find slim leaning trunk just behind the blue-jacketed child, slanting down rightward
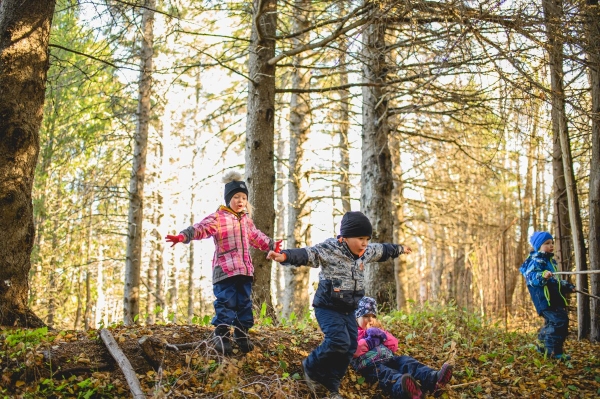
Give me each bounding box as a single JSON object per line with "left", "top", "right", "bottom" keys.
{"left": 542, "top": 0, "right": 590, "bottom": 339}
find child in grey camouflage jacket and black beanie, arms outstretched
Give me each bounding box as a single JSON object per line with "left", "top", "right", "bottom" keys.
{"left": 267, "top": 212, "right": 412, "bottom": 399}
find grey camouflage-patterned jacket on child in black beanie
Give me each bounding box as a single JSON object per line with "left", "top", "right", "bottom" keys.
{"left": 281, "top": 238, "right": 404, "bottom": 313}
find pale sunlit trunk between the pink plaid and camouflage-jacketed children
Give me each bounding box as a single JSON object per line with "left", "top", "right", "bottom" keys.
{"left": 282, "top": 0, "right": 311, "bottom": 318}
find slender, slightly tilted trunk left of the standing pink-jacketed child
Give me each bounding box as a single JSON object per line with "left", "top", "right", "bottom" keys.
{"left": 123, "top": 0, "right": 156, "bottom": 325}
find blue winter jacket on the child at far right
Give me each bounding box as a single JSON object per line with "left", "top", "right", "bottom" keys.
{"left": 519, "top": 251, "right": 575, "bottom": 315}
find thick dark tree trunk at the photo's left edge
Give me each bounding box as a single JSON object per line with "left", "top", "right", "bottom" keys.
{"left": 0, "top": 0, "right": 55, "bottom": 327}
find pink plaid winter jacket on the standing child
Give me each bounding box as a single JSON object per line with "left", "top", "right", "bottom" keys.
{"left": 181, "top": 206, "right": 273, "bottom": 283}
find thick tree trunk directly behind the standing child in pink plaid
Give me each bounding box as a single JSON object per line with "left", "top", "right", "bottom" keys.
{"left": 246, "top": 0, "right": 277, "bottom": 315}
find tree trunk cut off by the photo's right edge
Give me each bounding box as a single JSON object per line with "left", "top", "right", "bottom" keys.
{"left": 586, "top": 0, "right": 600, "bottom": 342}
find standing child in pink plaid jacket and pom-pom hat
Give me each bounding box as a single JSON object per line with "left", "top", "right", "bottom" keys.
{"left": 166, "top": 172, "right": 277, "bottom": 355}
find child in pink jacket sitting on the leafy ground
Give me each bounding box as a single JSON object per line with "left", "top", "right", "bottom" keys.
{"left": 351, "top": 296, "right": 452, "bottom": 399}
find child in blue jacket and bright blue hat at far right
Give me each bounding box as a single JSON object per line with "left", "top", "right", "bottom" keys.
{"left": 519, "top": 231, "right": 575, "bottom": 360}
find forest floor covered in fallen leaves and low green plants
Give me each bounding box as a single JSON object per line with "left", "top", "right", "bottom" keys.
{"left": 0, "top": 307, "right": 600, "bottom": 399}
